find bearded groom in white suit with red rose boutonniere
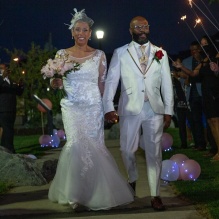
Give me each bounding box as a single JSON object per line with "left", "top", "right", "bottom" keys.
{"left": 103, "top": 16, "right": 173, "bottom": 211}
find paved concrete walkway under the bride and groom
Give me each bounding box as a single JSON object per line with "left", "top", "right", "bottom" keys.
{"left": 0, "top": 132, "right": 207, "bottom": 219}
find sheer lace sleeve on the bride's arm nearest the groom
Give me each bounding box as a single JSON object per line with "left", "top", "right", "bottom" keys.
{"left": 98, "top": 52, "right": 107, "bottom": 96}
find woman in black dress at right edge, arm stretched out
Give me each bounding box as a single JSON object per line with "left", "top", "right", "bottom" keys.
{"left": 173, "top": 45, "right": 219, "bottom": 161}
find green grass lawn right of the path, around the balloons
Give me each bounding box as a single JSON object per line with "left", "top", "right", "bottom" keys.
{"left": 163, "top": 129, "right": 219, "bottom": 219}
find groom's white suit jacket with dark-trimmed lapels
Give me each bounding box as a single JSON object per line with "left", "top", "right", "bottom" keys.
{"left": 103, "top": 42, "right": 173, "bottom": 116}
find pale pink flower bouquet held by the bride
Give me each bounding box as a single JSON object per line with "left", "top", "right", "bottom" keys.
{"left": 41, "top": 54, "right": 80, "bottom": 98}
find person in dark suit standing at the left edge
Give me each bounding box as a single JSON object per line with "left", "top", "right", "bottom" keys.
{"left": 0, "top": 64, "right": 24, "bottom": 153}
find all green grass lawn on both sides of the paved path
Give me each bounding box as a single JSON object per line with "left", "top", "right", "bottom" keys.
{"left": 0, "top": 128, "right": 219, "bottom": 219}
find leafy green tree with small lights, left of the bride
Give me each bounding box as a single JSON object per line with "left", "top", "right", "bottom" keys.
{"left": 6, "top": 43, "right": 60, "bottom": 127}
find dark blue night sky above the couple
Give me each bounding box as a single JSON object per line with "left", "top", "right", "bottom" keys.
{"left": 0, "top": 0, "right": 219, "bottom": 62}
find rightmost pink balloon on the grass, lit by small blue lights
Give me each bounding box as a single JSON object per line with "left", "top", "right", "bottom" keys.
{"left": 179, "top": 159, "right": 201, "bottom": 180}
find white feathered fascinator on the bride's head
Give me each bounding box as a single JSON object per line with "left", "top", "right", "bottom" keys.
{"left": 66, "top": 8, "right": 94, "bottom": 30}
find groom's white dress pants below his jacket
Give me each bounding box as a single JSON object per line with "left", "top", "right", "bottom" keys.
{"left": 119, "top": 101, "right": 164, "bottom": 196}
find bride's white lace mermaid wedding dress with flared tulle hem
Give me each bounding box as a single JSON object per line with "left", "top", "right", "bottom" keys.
{"left": 48, "top": 50, "right": 134, "bottom": 210}
